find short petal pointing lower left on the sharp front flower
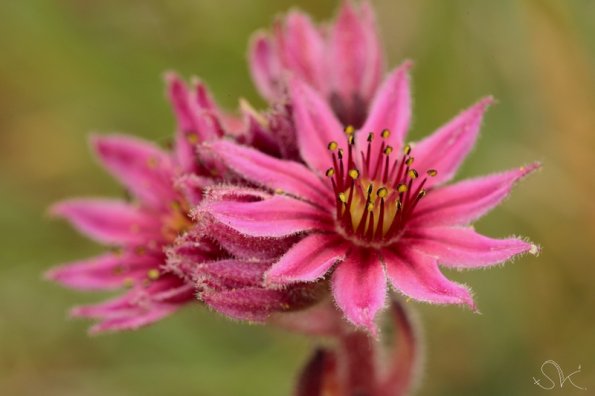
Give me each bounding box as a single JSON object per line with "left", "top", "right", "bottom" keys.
{"left": 265, "top": 234, "right": 348, "bottom": 284}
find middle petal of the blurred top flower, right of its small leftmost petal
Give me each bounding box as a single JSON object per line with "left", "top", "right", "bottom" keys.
{"left": 275, "top": 11, "right": 329, "bottom": 92}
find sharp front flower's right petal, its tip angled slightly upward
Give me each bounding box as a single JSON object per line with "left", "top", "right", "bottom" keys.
{"left": 410, "top": 163, "right": 541, "bottom": 227}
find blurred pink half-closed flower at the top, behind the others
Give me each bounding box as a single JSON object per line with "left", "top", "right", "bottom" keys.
{"left": 249, "top": 1, "right": 384, "bottom": 126}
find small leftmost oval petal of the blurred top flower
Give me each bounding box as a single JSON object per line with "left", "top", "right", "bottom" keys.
{"left": 248, "top": 32, "right": 281, "bottom": 101}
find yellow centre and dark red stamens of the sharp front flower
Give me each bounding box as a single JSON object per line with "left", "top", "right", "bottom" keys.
{"left": 326, "top": 126, "right": 438, "bottom": 243}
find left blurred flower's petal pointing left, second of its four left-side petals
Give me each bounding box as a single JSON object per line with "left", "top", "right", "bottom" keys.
{"left": 50, "top": 199, "right": 161, "bottom": 245}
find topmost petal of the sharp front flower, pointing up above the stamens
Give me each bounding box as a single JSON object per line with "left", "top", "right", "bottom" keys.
{"left": 357, "top": 61, "right": 412, "bottom": 158}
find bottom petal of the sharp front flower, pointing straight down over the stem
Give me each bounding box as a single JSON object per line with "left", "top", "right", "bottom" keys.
{"left": 332, "top": 248, "right": 386, "bottom": 335}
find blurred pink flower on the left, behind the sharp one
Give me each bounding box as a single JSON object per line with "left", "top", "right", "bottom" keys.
{"left": 47, "top": 74, "right": 240, "bottom": 333}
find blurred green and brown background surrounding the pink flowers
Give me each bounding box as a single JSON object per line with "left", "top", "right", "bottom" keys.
{"left": 0, "top": 0, "right": 595, "bottom": 396}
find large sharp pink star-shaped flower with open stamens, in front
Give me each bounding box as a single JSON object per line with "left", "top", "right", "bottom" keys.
{"left": 202, "top": 62, "right": 539, "bottom": 333}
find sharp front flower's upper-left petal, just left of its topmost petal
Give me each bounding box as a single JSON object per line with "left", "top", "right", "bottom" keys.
{"left": 289, "top": 78, "right": 346, "bottom": 174}
